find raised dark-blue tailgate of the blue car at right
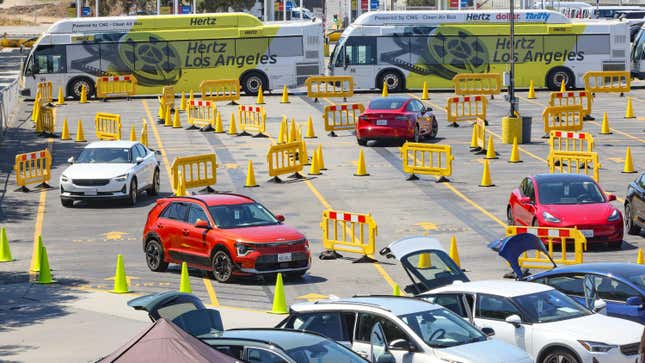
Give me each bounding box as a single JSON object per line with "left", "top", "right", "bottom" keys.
{"left": 488, "top": 233, "right": 557, "bottom": 280}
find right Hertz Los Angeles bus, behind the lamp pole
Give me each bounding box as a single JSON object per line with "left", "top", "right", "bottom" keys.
{"left": 327, "top": 10, "right": 630, "bottom": 91}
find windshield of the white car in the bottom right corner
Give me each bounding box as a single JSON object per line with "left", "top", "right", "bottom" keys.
{"left": 512, "top": 290, "right": 591, "bottom": 323}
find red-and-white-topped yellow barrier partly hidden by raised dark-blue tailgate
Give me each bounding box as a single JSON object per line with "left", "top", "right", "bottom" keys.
{"left": 506, "top": 226, "right": 587, "bottom": 269}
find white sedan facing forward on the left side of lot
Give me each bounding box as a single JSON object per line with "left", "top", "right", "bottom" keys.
{"left": 60, "top": 141, "right": 159, "bottom": 207}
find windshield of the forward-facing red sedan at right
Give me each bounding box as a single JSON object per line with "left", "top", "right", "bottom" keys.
{"left": 538, "top": 180, "right": 605, "bottom": 204}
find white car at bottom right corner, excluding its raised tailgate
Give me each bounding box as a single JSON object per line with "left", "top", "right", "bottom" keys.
{"left": 417, "top": 280, "right": 643, "bottom": 363}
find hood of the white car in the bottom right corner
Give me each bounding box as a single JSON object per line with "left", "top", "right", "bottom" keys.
{"left": 539, "top": 314, "right": 643, "bottom": 345}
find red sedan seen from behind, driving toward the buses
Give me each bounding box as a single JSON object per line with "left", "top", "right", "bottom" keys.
{"left": 356, "top": 96, "right": 438, "bottom": 146}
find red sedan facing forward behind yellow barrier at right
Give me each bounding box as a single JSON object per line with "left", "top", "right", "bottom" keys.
{"left": 506, "top": 174, "right": 623, "bottom": 248}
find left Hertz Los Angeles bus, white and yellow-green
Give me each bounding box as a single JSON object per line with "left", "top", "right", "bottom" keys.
{"left": 21, "top": 13, "right": 324, "bottom": 98}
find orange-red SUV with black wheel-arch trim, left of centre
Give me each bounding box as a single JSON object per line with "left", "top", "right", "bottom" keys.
{"left": 143, "top": 193, "right": 311, "bottom": 282}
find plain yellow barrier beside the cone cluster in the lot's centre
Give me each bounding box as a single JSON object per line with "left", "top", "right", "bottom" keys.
{"left": 267, "top": 140, "right": 307, "bottom": 183}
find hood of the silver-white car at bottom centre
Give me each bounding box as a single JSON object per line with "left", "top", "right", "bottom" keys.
{"left": 435, "top": 339, "right": 533, "bottom": 363}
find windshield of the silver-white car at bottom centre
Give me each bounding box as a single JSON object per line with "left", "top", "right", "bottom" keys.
{"left": 399, "top": 309, "right": 487, "bottom": 348}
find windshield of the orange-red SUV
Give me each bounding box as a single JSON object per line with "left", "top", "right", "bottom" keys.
{"left": 208, "top": 203, "right": 279, "bottom": 228}
